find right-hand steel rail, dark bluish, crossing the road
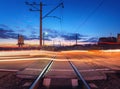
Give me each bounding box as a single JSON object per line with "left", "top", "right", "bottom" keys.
{"left": 68, "top": 59, "right": 91, "bottom": 89}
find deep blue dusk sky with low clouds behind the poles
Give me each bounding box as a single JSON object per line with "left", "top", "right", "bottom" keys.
{"left": 0, "top": 0, "right": 120, "bottom": 44}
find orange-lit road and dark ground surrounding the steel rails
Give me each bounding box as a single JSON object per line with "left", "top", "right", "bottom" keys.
{"left": 0, "top": 50, "right": 120, "bottom": 89}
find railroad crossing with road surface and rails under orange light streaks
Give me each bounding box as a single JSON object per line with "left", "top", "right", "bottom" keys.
{"left": 0, "top": 50, "right": 120, "bottom": 89}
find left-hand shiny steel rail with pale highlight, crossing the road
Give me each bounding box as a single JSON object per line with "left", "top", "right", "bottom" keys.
{"left": 29, "top": 60, "right": 53, "bottom": 89}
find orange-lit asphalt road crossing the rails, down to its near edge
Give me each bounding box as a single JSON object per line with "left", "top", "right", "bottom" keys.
{"left": 0, "top": 50, "right": 120, "bottom": 88}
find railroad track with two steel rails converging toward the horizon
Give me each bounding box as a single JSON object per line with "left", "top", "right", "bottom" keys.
{"left": 29, "top": 57, "right": 91, "bottom": 89}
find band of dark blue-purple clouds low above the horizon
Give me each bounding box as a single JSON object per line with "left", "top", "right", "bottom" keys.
{"left": 0, "top": 24, "right": 98, "bottom": 42}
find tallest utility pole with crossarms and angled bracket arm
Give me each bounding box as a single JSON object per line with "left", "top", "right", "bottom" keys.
{"left": 25, "top": 2, "right": 64, "bottom": 48}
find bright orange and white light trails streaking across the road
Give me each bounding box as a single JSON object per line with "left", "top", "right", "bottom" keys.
{"left": 0, "top": 49, "right": 120, "bottom": 62}
